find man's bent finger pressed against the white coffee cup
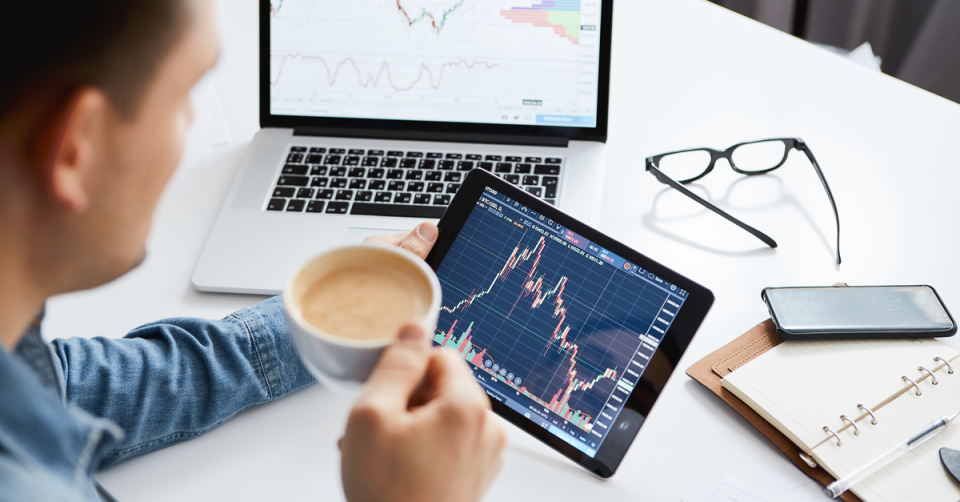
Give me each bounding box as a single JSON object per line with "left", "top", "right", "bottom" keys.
{"left": 358, "top": 324, "right": 433, "bottom": 411}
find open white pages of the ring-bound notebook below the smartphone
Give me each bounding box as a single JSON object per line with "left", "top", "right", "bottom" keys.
{"left": 721, "top": 332, "right": 960, "bottom": 502}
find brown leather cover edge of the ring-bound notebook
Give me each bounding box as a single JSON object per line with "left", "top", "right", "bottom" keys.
{"left": 687, "top": 319, "right": 863, "bottom": 502}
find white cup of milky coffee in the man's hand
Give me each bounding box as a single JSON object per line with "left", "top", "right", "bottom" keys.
{"left": 283, "top": 243, "right": 441, "bottom": 393}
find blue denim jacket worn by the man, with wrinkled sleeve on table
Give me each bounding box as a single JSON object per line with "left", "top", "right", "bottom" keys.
{"left": 0, "top": 297, "right": 314, "bottom": 502}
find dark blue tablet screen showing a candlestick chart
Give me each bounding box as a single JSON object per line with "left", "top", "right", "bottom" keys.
{"left": 433, "top": 187, "right": 688, "bottom": 457}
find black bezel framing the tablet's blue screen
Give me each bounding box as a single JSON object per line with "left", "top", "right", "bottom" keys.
{"left": 426, "top": 169, "right": 714, "bottom": 478}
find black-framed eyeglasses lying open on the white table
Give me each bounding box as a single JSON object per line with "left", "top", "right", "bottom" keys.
{"left": 647, "top": 138, "right": 840, "bottom": 265}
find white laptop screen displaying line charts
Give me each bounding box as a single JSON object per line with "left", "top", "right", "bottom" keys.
{"left": 269, "top": 0, "right": 607, "bottom": 129}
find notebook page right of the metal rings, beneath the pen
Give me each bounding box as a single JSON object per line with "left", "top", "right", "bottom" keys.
{"left": 813, "top": 357, "right": 960, "bottom": 502}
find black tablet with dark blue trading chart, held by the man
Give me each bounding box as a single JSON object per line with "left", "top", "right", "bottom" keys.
{"left": 427, "top": 169, "right": 713, "bottom": 478}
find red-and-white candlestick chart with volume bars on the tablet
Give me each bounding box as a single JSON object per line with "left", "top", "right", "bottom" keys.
{"left": 434, "top": 237, "right": 617, "bottom": 430}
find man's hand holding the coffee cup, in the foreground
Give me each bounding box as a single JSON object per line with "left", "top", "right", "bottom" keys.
{"left": 340, "top": 324, "right": 505, "bottom": 502}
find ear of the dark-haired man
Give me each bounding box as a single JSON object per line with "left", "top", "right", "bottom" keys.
{"left": 29, "top": 87, "right": 110, "bottom": 212}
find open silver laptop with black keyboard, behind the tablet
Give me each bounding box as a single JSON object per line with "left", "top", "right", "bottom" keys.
{"left": 192, "top": 0, "right": 613, "bottom": 294}
